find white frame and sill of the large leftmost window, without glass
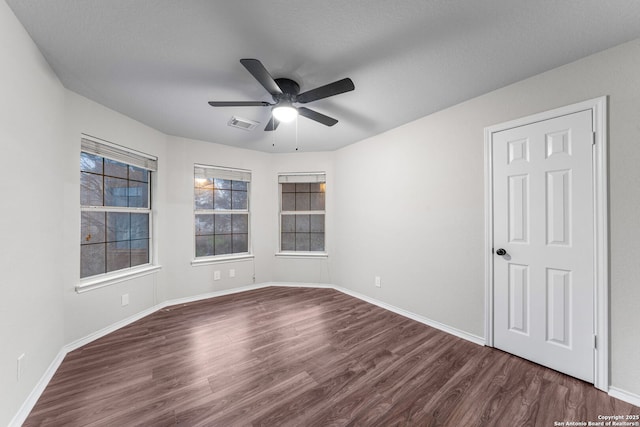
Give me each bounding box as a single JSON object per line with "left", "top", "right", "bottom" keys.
{"left": 76, "top": 134, "right": 161, "bottom": 293}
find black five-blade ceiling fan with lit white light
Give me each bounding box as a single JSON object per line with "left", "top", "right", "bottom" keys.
{"left": 209, "top": 59, "right": 355, "bottom": 131}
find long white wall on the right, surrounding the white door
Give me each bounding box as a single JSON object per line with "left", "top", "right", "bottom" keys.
{"left": 334, "top": 40, "right": 640, "bottom": 395}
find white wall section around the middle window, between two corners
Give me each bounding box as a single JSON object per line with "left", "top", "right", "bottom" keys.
{"left": 163, "top": 137, "right": 273, "bottom": 299}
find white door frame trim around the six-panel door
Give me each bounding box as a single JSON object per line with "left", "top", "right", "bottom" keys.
{"left": 484, "top": 96, "right": 609, "bottom": 392}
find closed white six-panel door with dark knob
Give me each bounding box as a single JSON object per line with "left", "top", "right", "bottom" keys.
{"left": 492, "top": 110, "right": 594, "bottom": 383}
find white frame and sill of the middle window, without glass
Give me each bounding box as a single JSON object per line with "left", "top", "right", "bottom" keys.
{"left": 191, "top": 163, "right": 254, "bottom": 266}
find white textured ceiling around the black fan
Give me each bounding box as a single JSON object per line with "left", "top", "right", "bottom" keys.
{"left": 7, "top": 0, "right": 640, "bottom": 152}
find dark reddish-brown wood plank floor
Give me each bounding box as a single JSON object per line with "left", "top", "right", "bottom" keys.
{"left": 24, "top": 287, "right": 640, "bottom": 427}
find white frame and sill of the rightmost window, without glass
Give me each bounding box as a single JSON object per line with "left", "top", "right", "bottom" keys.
{"left": 275, "top": 172, "right": 329, "bottom": 258}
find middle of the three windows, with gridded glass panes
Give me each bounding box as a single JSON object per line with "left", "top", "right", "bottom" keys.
{"left": 193, "top": 165, "right": 251, "bottom": 259}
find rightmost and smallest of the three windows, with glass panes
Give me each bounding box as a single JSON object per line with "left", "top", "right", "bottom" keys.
{"left": 278, "top": 173, "right": 325, "bottom": 253}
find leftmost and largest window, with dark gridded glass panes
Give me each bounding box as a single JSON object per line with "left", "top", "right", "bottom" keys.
{"left": 80, "top": 138, "right": 157, "bottom": 278}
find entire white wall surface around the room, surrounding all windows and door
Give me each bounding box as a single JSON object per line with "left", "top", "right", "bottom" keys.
{"left": 0, "top": 2, "right": 640, "bottom": 425}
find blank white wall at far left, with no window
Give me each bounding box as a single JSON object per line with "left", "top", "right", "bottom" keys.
{"left": 0, "top": 1, "right": 65, "bottom": 425}
